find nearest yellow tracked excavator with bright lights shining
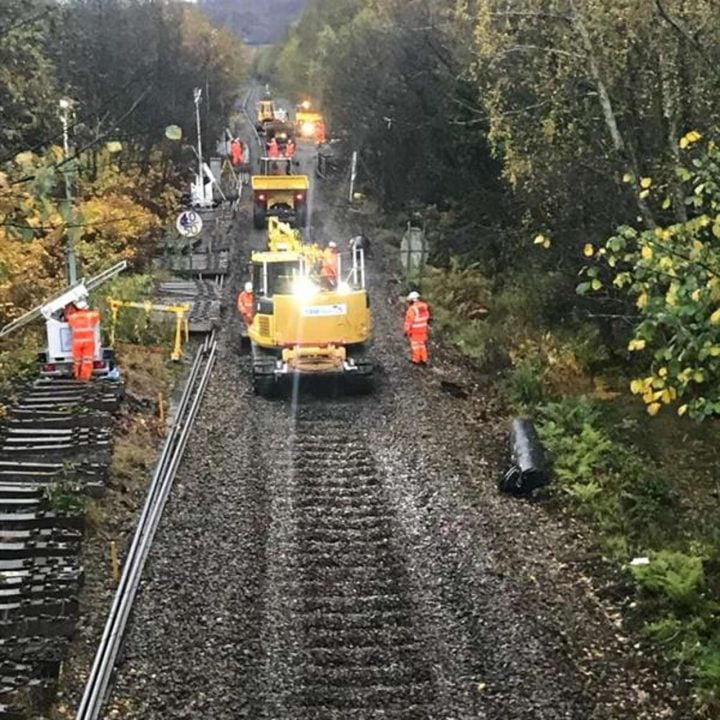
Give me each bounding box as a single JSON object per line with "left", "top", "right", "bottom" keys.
{"left": 249, "top": 238, "right": 373, "bottom": 395}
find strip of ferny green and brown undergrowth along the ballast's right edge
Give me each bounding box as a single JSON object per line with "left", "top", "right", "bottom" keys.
{"left": 422, "top": 261, "right": 720, "bottom": 717}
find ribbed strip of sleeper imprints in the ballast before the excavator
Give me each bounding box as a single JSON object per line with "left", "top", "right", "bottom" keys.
{"left": 264, "top": 408, "right": 436, "bottom": 720}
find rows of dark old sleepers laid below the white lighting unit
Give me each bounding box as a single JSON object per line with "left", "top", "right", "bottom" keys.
{"left": 0, "top": 379, "right": 122, "bottom": 720}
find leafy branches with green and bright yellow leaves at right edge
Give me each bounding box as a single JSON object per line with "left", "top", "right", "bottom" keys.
{"left": 579, "top": 133, "right": 720, "bottom": 420}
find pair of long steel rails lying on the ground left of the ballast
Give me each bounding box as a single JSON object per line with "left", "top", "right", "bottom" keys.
{"left": 76, "top": 332, "right": 217, "bottom": 720}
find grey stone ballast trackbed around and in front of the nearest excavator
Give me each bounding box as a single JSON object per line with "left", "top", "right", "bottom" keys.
{"left": 98, "top": 98, "right": 691, "bottom": 720}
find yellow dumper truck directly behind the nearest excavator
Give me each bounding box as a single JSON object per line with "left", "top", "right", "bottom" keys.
{"left": 250, "top": 168, "right": 310, "bottom": 230}
